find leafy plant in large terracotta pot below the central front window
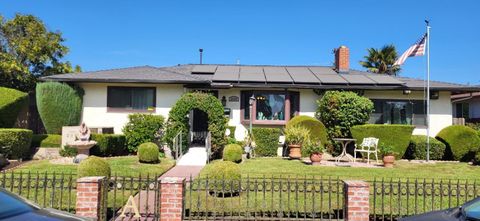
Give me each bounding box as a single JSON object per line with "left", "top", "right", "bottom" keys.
{"left": 285, "top": 127, "right": 309, "bottom": 159}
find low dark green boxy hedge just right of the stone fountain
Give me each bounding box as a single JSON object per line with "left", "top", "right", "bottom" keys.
{"left": 90, "top": 134, "right": 128, "bottom": 157}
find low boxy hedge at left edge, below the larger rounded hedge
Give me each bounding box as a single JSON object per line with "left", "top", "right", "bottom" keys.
{"left": 0, "top": 128, "right": 33, "bottom": 159}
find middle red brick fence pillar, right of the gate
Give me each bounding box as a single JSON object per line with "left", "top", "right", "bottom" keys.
{"left": 160, "top": 177, "right": 185, "bottom": 221}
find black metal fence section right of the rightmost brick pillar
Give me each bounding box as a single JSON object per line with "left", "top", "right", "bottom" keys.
{"left": 370, "top": 179, "right": 480, "bottom": 220}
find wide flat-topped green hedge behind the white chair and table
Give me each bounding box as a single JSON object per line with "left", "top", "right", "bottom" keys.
{"left": 351, "top": 124, "right": 414, "bottom": 159}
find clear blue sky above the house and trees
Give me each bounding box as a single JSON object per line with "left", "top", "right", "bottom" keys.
{"left": 0, "top": 0, "right": 480, "bottom": 84}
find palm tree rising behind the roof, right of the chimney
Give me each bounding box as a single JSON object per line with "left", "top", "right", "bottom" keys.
{"left": 360, "top": 45, "right": 400, "bottom": 76}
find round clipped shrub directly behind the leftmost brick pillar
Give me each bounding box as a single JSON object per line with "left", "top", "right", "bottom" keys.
{"left": 77, "top": 156, "right": 111, "bottom": 177}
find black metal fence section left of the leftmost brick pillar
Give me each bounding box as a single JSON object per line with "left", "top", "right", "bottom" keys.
{"left": 0, "top": 172, "right": 77, "bottom": 212}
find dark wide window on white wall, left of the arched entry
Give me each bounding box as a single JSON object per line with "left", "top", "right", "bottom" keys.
{"left": 107, "top": 87, "right": 155, "bottom": 111}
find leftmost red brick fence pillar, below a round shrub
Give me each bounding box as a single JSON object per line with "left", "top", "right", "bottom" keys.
{"left": 76, "top": 176, "right": 105, "bottom": 219}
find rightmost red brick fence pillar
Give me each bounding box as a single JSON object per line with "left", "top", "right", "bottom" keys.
{"left": 343, "top": 180, "right": 370, "bottom": 221}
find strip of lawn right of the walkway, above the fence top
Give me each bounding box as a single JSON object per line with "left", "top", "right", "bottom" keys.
{"left": 220, "top": 158, "right": 480, "bottom": 180}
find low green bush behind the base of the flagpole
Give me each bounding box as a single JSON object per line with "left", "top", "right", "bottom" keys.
{"left": 403, "top": 135, "right": 446, "bottom": 160}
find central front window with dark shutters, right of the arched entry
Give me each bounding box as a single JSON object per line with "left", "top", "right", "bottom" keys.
{"left": 241, "top": 91, "right": 300, "bottom": 124}
